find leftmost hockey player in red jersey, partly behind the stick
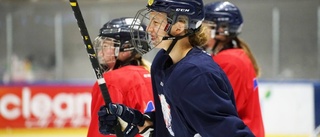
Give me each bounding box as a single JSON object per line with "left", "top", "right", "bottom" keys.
{"left": 87, "top": 17, "right": 154, "bottom": 137}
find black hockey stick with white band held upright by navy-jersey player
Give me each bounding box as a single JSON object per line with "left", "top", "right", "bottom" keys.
{"left": 69, "top": 0, "right": 123, "bottom": 137}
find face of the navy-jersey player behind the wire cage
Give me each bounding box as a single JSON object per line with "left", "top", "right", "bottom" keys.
{"left": 147, "top": 11, "right": 168, "bottom": 46}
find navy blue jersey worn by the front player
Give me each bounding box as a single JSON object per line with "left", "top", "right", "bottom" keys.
{"left": 151, "top": 47, "right": 253, "bottom": 137}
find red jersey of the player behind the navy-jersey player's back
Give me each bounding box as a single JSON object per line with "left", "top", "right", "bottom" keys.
{"left": 213, "top": 49, "right": 264, "bottom": 137}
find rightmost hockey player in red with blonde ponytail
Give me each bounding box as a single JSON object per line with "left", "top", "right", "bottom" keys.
{"left": 203, "top": 2, "right": 264, "bottom": 137}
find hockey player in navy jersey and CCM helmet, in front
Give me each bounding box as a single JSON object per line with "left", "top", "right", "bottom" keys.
{"left": 97, "top": 0, "right": 253, "bottom": 137}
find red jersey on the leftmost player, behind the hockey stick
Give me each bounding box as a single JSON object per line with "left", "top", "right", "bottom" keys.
{"left": 87, "top": 65, "right": 154, "bottom": 137}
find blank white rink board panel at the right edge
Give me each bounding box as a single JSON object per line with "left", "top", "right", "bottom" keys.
{"left": 259, "top": 81, "right": 320, "bottom": 137}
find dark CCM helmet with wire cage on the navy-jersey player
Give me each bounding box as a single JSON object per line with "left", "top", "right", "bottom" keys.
{"left": 129, "top": 0, "right": 204, "bottom": 53}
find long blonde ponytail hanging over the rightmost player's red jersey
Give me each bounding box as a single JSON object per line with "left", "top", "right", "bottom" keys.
{"left": 235, "top": 37, "right": 260, "bottom": 77}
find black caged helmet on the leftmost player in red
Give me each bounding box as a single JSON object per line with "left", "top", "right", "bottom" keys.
{"left": 93, "top": 17, "right": 150, "bottom": 70}
